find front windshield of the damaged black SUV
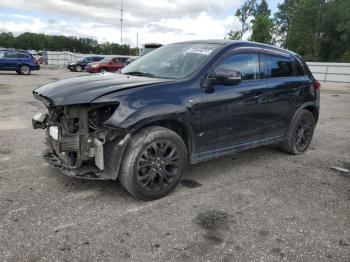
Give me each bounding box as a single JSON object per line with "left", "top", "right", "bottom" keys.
{"left": 121, "top": 43, "right": 221, "bottom": 79}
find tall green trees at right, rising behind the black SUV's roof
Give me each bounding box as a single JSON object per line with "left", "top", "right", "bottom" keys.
{"left": 227, "top": 0, "right": 350, "bottom": 62}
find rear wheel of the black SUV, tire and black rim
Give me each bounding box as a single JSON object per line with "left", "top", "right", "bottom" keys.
{"left": 281, "top": 110, "right": 316, "bottom": 155}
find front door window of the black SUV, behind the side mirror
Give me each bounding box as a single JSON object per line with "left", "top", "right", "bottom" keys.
{"left": 217, "top": 53, "right": 260, "bottom": 80}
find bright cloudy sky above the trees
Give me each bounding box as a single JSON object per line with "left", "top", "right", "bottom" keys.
{"left": 0, "top": 0, "right": 283, "bottom": 47}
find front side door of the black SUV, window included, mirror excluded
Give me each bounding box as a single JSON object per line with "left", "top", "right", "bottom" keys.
{"left": 199, "top": 49, "right": 268, "bottom": 154}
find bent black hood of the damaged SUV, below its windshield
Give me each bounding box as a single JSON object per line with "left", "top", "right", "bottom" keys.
{"left": 33, "top": 73, "right": 172, "bottom": 106}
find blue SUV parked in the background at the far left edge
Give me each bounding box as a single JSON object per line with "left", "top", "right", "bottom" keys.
{"left": 0, "top": 50, "right": 40, "bottom": 75}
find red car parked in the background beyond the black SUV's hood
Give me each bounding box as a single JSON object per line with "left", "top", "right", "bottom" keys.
{"left": 86, "top": 57, "right": 128, "bottom": 73}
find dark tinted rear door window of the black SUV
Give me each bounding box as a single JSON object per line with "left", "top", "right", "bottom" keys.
{"left": 267, "top": 56, "right": 294, "bottom": 77}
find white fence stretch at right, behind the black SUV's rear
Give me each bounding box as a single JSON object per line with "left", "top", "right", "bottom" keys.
{"left": 307, "top": 62, "right": 350, "bottom": 83}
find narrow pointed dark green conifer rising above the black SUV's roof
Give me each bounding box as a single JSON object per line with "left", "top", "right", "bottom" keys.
{"left": 250, "top": 0, "right": 274, "bottom": 44}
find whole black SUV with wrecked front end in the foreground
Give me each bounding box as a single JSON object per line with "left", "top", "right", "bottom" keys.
{"left": 33, "top": 40, "right": 320, "bottom": 200}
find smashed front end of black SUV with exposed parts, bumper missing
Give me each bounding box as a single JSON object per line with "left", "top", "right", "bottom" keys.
{"left": 32, "top": 96, "right": 131, "bottom": 180}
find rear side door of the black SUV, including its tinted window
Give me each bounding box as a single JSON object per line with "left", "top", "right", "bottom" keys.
{"left": 263, "top": 50, "right": 307, "bottom": 137}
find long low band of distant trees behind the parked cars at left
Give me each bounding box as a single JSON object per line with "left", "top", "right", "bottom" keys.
{"left": 0, "top": 32, "right": 138, "bottom": 55}
